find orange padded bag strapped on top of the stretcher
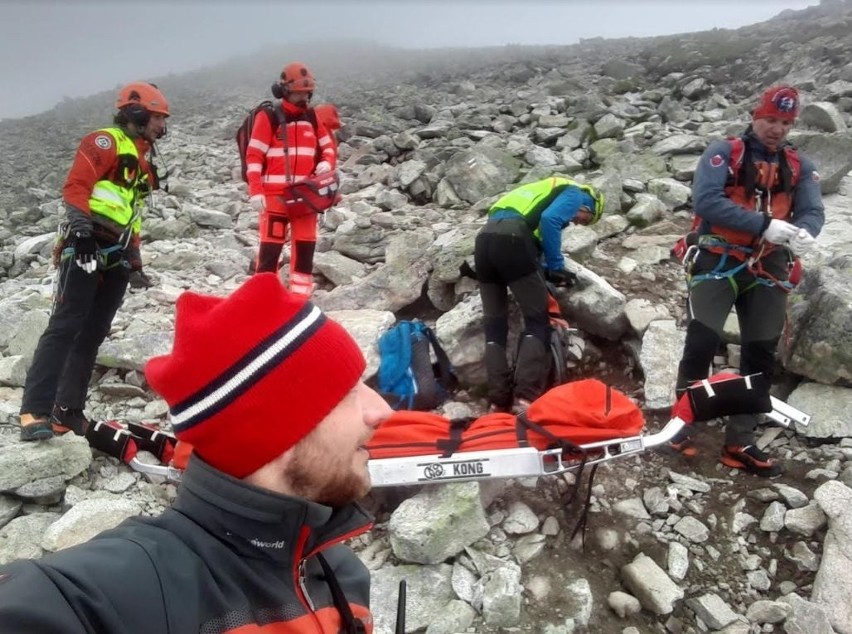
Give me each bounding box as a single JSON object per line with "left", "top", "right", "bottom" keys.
{"left": 367, "top": 379, "right": 645, "bottom": 460}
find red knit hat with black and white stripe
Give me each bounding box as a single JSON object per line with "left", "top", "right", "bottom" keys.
{"left": 145, "top": 273, "right": 366, "bottom": 478}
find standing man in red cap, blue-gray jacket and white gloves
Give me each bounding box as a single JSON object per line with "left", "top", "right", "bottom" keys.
{"left": 672, "top": 85, "right": 825, "bottom": 477}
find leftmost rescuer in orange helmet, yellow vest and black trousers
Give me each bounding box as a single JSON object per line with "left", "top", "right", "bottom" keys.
{"left": 21, "top": 82, "right": 169, "bottom": 441}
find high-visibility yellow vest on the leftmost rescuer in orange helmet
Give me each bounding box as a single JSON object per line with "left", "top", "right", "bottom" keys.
{"left": 89, "top": 128, "right": 148, "bottom": 233}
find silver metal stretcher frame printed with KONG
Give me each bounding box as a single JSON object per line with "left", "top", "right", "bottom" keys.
{"left": 128, "top": 396, "right": 811, "bottom": 487}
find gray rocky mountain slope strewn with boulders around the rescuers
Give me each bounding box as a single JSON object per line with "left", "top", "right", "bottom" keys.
{"left": 0, "top": 1, "right": 852, "bottom": 634}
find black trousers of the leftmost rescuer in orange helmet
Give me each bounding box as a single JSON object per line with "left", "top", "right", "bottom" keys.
{"left": 21, "top": 252, "right": 130, "bottom": 415}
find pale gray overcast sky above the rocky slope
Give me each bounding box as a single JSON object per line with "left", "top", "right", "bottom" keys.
{"left": 0, "top": 0, "right": 818, "bottom": 118}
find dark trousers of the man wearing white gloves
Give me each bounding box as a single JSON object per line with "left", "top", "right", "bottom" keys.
{"left": 677, "top": 249, "right": 789, "bottom": 446}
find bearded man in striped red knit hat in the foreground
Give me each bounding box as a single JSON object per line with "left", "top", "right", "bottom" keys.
{"left": 0, "top": 273, "right": 390, "bottom": 634}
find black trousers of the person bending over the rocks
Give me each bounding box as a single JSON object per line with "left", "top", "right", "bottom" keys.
{"left": 474, "top": 218, "right": 550, "bottom": 407}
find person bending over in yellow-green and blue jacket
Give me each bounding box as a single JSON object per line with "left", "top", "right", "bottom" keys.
{"left": 474, "top": 176, "right": 604, "bottom": 411}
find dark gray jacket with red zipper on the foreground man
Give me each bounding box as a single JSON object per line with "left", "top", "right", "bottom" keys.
{"left": 0, "top": 456, "right": 372, "bottom": 634}
